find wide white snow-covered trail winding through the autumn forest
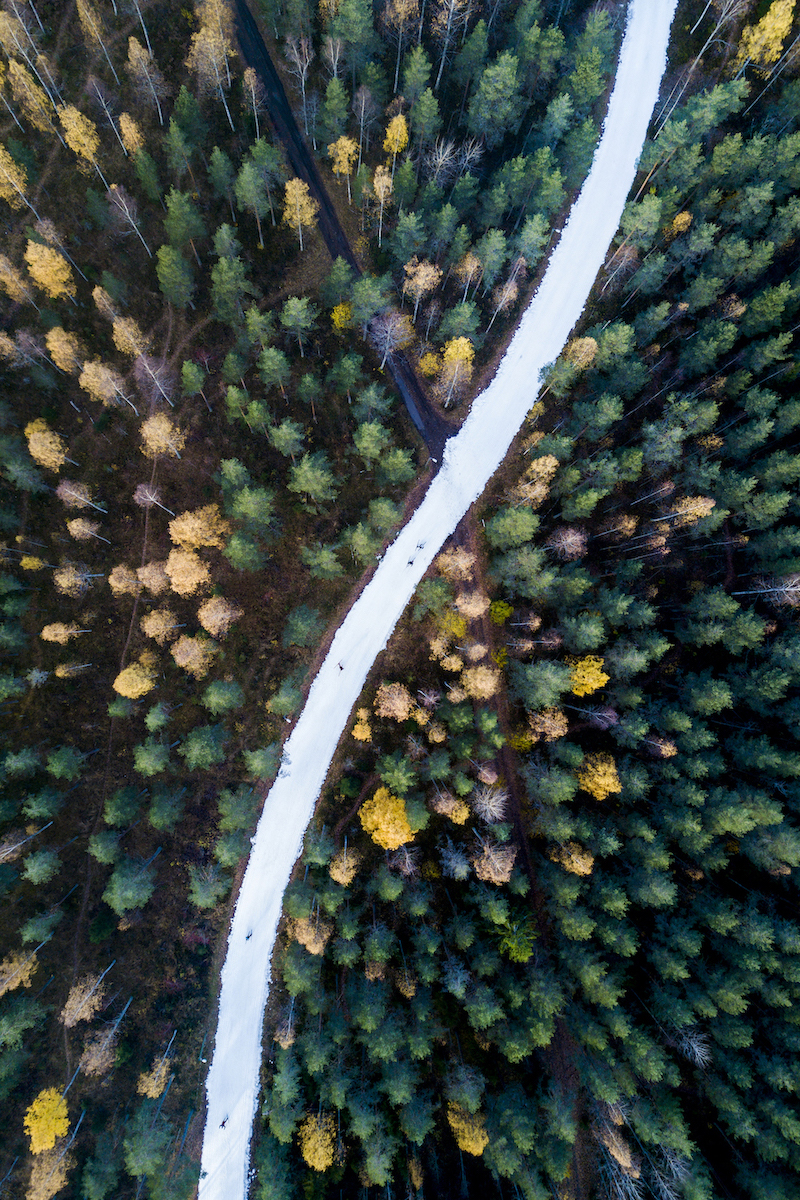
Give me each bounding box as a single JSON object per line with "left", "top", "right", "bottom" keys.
{"left": 199, "top": 0, "right": 678, "bottom": 1200}
